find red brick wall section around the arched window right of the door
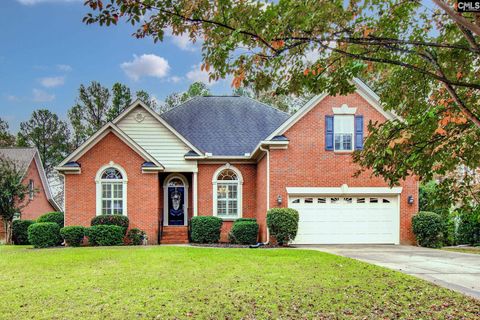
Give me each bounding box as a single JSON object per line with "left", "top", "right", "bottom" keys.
{"left": 198, "top": 163, "right": 257, "bottom": 242}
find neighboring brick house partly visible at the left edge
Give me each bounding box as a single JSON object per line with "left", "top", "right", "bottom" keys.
{"left": 0, "top": 148, "right": 61, "bottom": 240}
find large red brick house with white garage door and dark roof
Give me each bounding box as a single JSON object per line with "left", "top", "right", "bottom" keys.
{"left": 57, "top": 79, "right": 418, "bottom": 244}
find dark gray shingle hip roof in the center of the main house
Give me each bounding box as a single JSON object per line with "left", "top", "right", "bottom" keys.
{"left": 161, "top": 96, "right": 290, "bottom": 156}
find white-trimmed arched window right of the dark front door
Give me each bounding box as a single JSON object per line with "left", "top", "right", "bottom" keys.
{"left": 213, "top": 165, "right": 243, "bottom": 219}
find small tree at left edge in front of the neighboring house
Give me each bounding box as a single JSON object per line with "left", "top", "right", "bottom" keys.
{"left": 0, "top": 158, "right": 35, "bottom": 244}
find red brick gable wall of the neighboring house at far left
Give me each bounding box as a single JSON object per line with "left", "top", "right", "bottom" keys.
{"left": 21, "top": 159, "right": 56, "bottom": 220}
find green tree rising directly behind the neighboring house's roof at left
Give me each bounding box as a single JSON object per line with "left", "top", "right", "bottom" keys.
{"left": 17, "top": 109, "right": 70, "bottom": 176}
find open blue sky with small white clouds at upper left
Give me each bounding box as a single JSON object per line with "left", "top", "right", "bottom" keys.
{"left": 0, "top": 0, "right": 232, "bottom": 133}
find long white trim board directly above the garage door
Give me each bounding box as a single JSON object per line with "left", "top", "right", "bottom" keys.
{"left": 287, "top": 186, "right": 402, "bottom": 196}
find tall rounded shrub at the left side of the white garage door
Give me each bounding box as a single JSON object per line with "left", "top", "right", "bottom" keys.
{"left": 267, "top": 208, "right": 299, "bottom": 245}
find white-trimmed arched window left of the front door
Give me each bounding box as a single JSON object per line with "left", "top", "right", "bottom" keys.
{"left": 96, "top": 163, "right": 127, "bottom": 215}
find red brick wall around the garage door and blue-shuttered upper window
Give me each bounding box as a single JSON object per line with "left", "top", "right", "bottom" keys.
{"left": 270, "top": 93, "right": 418, "bottom": 243}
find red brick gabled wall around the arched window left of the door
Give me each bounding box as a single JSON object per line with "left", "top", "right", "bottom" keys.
{"left": 65, "top": 133, "right": 161, "bottom": 244}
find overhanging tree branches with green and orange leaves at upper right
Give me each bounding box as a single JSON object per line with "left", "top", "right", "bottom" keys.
{"left": 84, "top": 0, "right": 480, "bottom": 202}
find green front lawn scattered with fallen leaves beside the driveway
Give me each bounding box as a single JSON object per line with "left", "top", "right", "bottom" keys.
{"left": 0, "top": 246, "right": 480, "bottom": 319}
